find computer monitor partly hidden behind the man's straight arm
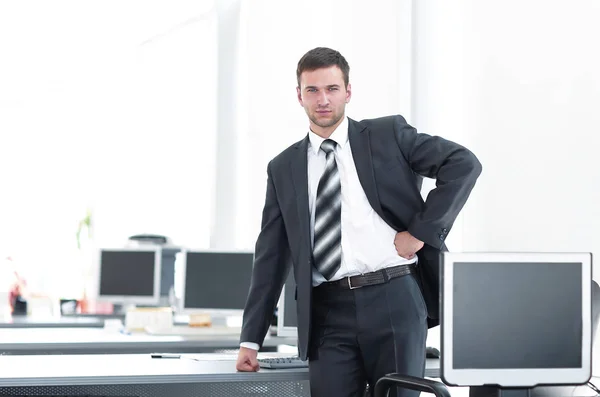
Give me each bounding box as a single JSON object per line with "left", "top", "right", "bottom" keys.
{"left": 178, "top": 250, "right": 254, "bottom": 315}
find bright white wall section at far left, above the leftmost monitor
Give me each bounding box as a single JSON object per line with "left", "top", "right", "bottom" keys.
{"left": 0, "top": 0, "right": 217, "bottom": 296}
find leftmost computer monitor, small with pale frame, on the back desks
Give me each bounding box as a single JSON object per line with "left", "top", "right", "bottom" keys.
{"left": 98, "top": 247, "right": 162, "bottom": 305}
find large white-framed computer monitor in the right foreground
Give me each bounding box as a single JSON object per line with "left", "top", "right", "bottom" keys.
{"left": 441, "top": 253, "right": 592, "bottom": 388}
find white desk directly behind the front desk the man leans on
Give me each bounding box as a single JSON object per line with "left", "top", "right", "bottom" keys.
{"left": 0, "top": 328, "right": 297, "bottom": 354}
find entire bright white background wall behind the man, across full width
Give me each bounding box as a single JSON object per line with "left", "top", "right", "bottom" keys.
{"left": 0, "top": 0, "right": 600, "bottom": 306}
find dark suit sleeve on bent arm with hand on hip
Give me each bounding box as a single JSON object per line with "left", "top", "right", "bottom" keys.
{"left": 393, "top": 116, "right": 482, "bottom": 249}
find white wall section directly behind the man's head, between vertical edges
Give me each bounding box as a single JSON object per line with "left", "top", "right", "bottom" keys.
{"left": 232, "top": 0, "right": 412, "bottom": 247}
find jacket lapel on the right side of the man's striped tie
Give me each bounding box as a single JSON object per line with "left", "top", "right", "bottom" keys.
{"left": 348, "top": 118, "right": 385, "bottom": 219}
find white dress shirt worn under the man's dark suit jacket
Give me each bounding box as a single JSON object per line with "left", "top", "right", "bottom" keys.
{"left": 240, "top": 117, "right": 417, "bottom": 350}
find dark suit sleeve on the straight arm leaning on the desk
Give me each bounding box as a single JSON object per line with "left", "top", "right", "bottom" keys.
{"left": 240, "top": 162, "right": 291, "bottom": 346}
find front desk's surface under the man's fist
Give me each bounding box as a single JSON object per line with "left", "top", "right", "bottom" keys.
{"left": 0, "top": 353, "right": 439, "bottom": 387}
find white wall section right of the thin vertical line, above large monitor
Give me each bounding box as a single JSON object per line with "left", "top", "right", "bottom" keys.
{"left": 411, "top": 0, "right": 600, "bottom": 358}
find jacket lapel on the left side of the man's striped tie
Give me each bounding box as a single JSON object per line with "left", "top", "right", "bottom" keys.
{"left": 290, "top": 135, "right": 310, "bottom": 247}
